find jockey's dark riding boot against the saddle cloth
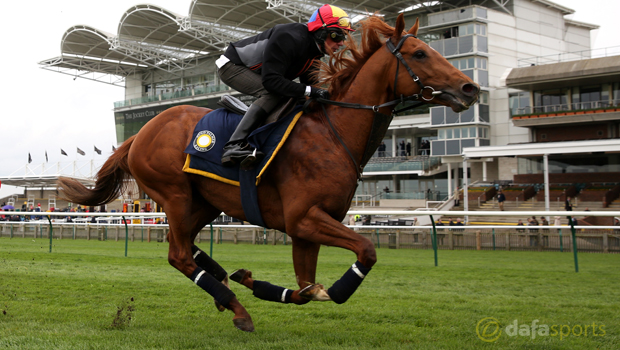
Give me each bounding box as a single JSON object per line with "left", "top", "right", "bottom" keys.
{"left": 222, "top": 104, "right": 268, "bottom": 167}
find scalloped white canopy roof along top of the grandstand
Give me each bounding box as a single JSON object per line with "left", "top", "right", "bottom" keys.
{"left": 39, "top": 0, "right": 528, "bottom": 87}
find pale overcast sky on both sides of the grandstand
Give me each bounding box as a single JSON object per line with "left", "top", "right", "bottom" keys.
{"left": 0, "top": 0, "right": 620, "bottom": 198}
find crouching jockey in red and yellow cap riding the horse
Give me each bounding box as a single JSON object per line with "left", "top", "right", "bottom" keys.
{"left": 215, "top": 5, "right": 353, "bottom": 167}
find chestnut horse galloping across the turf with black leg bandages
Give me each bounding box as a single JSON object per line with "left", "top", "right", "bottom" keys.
{"left": 59, "top": 14, "right": 479, "bottom": 331}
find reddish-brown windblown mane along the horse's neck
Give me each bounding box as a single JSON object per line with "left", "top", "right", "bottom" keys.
{"left": 318, "top": 14, "right": 394, "bottom": 98}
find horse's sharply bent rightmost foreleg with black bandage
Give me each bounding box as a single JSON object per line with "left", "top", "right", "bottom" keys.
{"left": 287, "top": 206, "right": 377, "bottom": 304}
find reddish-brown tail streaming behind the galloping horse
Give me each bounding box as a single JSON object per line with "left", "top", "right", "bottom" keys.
{"left": 58, "top": 135, "right": 135, "bottom": 206}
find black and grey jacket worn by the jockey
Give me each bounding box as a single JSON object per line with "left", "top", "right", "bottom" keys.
{"left": 224, "top": 23, "right": 323, "bottom": 97}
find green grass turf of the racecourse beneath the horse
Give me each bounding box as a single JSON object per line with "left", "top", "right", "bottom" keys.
{"left": 0, "top": 238, "right": 620, "bottom": 350}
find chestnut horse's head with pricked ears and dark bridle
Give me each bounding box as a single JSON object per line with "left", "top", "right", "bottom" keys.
{"left": 387, "top": 14, "right": 480, "bottom": 112}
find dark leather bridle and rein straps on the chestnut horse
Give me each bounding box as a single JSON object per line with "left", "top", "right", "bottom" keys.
{"left": 314, "top": 34, "right": 442, "bottom": 181}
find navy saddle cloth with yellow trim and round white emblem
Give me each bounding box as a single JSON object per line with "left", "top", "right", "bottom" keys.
{"left": 183, "top": 106, "right": 302, "bottom": 227}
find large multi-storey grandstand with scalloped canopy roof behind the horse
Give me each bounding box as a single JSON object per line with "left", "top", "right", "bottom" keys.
{"left": 40, "top": 0, "right": 620, "bottom": 211}
